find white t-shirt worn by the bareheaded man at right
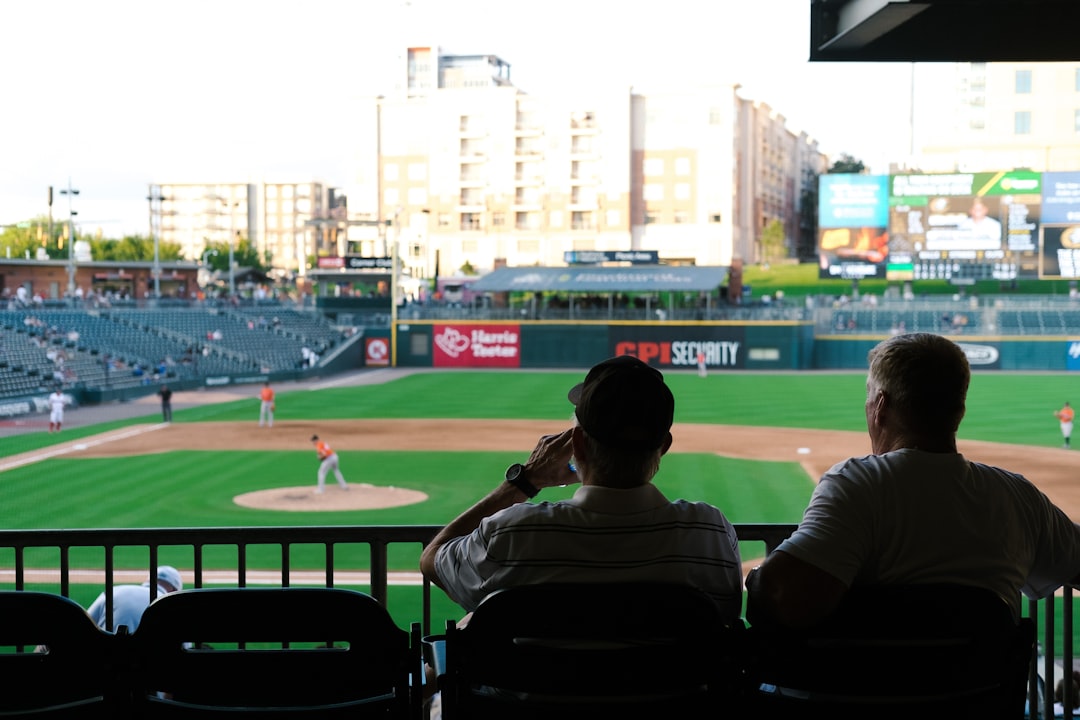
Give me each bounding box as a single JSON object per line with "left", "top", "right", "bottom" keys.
{"left": 778, "top": 449, "right": 1080, "bottom": 616}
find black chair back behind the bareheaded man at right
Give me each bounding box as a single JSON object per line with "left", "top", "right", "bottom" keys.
{"left": 747, "top": 585, "right": 1035, "bottom": 720}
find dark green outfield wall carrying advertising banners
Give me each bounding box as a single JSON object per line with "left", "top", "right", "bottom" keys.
{"left": 390, "top": 321, "right": 1080, "bottom": 371}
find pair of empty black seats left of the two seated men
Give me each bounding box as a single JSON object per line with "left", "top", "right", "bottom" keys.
{"left": 0, "top": 587, "right": 423, "bottom": 720}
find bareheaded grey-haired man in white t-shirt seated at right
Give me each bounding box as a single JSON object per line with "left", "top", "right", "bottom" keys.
{"left": 746, "top": 332, "right": 1080, "bottom": 627}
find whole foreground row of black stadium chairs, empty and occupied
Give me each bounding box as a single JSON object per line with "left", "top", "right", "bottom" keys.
{"left": 0, "top": 583, "right": 1035, "bottom": 720}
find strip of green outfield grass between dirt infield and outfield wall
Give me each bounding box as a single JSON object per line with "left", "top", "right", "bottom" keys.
{"left": 143, "top": 370, "right": 1080, "bottom": 449}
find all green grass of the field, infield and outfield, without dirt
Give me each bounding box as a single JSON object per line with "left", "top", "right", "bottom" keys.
{"left": 0, "top": 370, "right": 1080, "bottom": 623}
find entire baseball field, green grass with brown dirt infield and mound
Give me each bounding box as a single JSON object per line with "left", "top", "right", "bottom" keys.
{"left": 0, "top": 370, "right": 1080, "bottom": 623}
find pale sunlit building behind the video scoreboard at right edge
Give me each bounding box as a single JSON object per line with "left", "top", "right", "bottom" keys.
{"left": 915, "top": 63, "right": 1080, "bottom": 172}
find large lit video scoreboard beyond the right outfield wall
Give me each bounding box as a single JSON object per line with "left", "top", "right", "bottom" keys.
{"left": 818, "top": 171, "right": 1067, "bottom": 284}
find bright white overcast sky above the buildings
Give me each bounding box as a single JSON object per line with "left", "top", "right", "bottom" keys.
{"left": 0, "top": 0, "right": 912, "bottom": 236}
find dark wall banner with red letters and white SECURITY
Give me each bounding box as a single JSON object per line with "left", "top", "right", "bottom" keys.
{"left": 608, "top": 325, "right": 746, "bottom": 370}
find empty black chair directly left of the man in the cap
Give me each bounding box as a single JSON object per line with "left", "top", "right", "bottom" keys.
{"left": 132, "top": 587, "right": 422, "bottom": 720}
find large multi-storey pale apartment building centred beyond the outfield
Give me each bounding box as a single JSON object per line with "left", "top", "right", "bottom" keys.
{"left": 349, "top": 47, "right": 826, "bottom": 277}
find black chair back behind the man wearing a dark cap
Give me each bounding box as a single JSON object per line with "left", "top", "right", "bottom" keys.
{"left": 431, "top": 583, "right": 743, "bottom": 720}
